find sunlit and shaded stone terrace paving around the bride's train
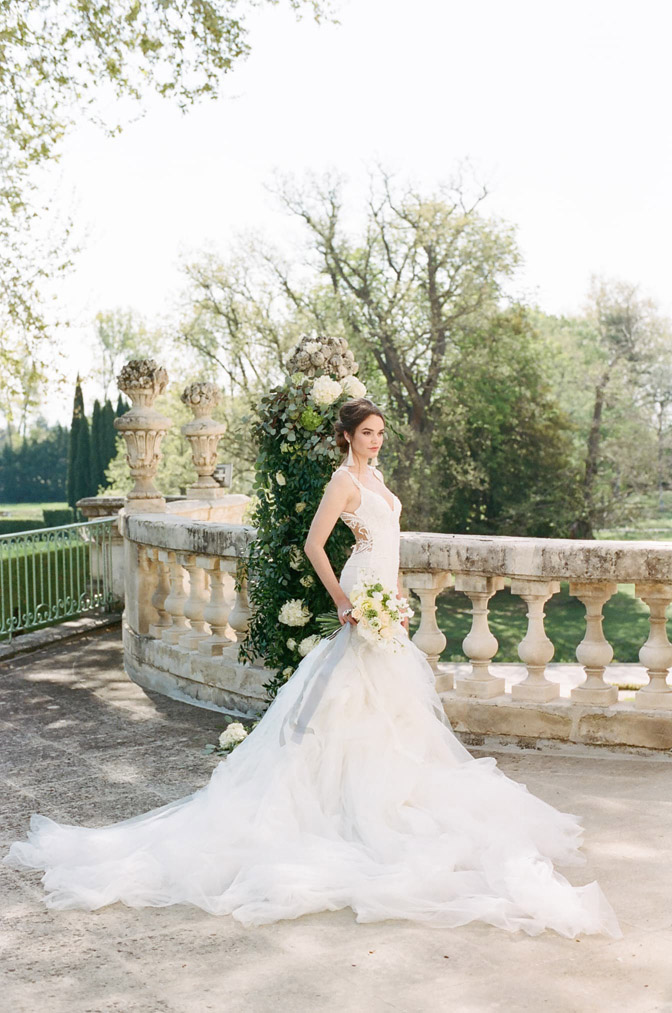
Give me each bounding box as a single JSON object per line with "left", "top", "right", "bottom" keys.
{"left": 0, "top": 631, "right": 672, "bottom": 1013}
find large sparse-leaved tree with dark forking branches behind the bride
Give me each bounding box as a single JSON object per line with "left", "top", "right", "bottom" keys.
{"left": 180, "top": 169, "right": 519, "bottom": 530}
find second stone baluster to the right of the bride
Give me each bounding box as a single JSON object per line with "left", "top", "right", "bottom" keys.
{"left": 455, "top": 573, "right": 506, "bottom": 700}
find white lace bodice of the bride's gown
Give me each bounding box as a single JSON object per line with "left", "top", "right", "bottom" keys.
{"left": 334, "top": 464, "right": 401, "bottom": 594}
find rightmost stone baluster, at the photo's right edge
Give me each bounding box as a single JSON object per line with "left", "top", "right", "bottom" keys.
{"left": 634, "top": 582, "right": 672, "bottom": 710}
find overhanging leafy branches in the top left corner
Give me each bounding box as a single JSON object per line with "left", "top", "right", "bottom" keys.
{"left": 0, "top": 0, "right": 328, "bottom": 403}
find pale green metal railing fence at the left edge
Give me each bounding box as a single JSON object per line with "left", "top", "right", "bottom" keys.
{"left": 0, "top": 518, "right": 119, "bottom": 640}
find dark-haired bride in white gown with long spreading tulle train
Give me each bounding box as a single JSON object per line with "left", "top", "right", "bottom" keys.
{"left": 3, "top": 398, "right": 620, "bottom": 937}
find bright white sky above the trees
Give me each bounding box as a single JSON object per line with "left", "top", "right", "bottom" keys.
{"left": 43, "top": 0, "right": 672, "bottom": 421}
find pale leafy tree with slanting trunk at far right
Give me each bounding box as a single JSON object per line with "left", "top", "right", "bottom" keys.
{"left": 535, "top": 278, "right": 670, "bottom": 538}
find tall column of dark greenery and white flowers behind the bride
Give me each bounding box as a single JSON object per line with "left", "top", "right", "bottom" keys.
{"left": 239, "top": 337, "right": 366, "bottom": 697}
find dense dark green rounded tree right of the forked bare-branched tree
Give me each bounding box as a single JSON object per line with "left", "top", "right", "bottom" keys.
{"left": 436, "top": 307, "right": 581, "bottom": 538}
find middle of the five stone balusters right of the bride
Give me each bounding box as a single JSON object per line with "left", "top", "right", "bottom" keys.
{"left": 511, "top": 577, "right": 559, "bottom": 703}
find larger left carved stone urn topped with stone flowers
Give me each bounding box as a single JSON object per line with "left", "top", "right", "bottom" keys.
{"left": 115, "top": 359, "right": 172, "bottom": 513}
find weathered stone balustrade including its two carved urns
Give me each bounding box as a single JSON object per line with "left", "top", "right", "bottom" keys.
{"left": 110, "top": 360, "right": 672, "bottom": 749}
